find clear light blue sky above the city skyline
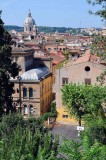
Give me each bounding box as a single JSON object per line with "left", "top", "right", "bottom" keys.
{"left": 0, "top": 0, "right": 103, "bottom": 28}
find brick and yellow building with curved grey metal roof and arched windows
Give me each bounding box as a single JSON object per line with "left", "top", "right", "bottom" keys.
{"left": 11, "top": 47, "right": 52, "bottom": 118}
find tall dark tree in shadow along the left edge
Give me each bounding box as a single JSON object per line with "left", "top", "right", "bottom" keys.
{"left": 0, "top": 13, "right": 19, "bottom": 116}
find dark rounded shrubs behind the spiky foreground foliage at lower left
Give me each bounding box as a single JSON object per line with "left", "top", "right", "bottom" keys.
{"left": 0, "top": 114, "right": 43, "bottom": 137}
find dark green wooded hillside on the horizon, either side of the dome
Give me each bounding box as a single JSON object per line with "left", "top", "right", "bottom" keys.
{"left": 5, "top": 25, "right": 80, "bottom": 34}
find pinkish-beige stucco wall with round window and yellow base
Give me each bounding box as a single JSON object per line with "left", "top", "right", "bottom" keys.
{"left": 55, "top": 61, "right": 106, "bottom": 122}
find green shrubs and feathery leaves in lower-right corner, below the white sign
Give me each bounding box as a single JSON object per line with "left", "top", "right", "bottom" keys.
{"left": 60, "top": 115, "right": 106, "bottom": 160}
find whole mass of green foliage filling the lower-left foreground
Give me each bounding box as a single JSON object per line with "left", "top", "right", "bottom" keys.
{"left": 0, "top": 115, "right": 58, "bottom": 160}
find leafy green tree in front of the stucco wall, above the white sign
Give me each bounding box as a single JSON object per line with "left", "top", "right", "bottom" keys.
{"left": 61, "top": 83, "right": 106, "bottom": 125}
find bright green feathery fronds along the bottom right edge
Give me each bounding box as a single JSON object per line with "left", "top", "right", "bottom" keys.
{"left": 60, "top": 136, "right": 106, "bottom": 160}
